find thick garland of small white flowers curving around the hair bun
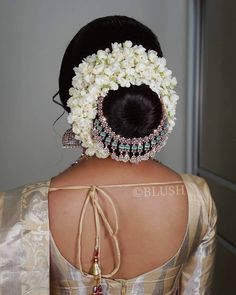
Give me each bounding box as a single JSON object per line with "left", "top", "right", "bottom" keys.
{"left": 67, "top": 41, "right": 179, "bottom": 158}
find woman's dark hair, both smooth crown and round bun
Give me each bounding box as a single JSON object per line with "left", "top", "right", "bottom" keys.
{"left": 59, "top": 15, "right": 163, "bottom": 137}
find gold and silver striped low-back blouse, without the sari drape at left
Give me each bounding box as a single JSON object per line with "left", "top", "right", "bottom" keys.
{"left": 50, "top": 174, "right": 216, "bottom": 295}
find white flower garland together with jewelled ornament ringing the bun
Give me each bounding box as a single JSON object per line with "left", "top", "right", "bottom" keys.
{"left": 64, "top": 41, "right": 179, "bottom": 163}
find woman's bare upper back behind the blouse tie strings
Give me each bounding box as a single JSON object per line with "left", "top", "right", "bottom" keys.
{"left": 49, "top": 158, "right": 188, "bottom": 279}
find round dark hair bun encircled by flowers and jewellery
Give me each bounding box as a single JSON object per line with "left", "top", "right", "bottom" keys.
{"left": 103, "top": 84, "right": 163, "bottom": 138}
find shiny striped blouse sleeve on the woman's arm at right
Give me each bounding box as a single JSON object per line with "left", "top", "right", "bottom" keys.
{"left": 178, "top": 180, "right": 217, "bottom": 295}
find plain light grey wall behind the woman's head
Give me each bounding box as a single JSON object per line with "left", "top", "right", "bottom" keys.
{"left": 0, "top": 0, "right": 187, "bottom": 190}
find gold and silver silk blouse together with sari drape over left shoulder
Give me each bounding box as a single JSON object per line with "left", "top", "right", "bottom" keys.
{"left": 0, "top": 174, "right": 217, "bottom": 295}
